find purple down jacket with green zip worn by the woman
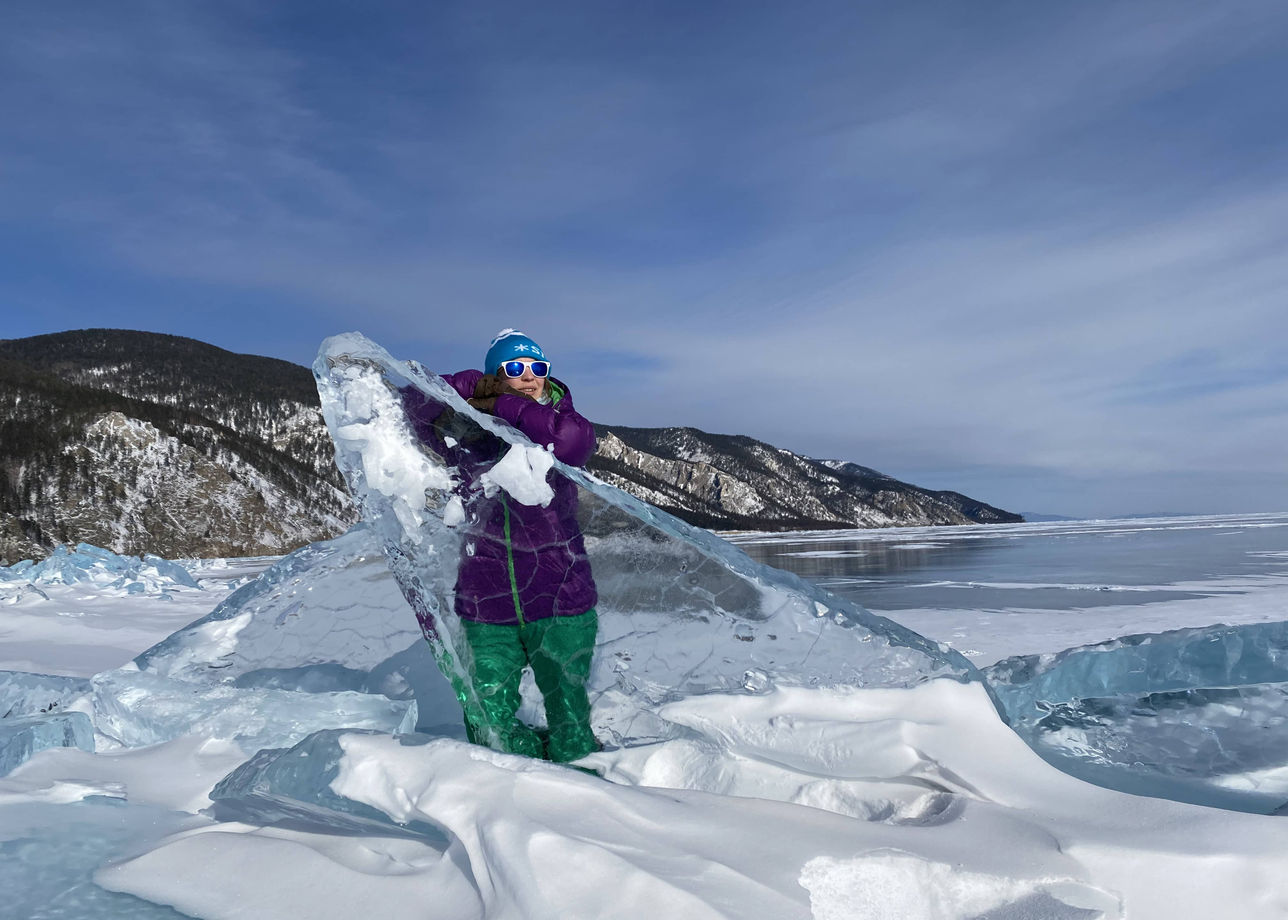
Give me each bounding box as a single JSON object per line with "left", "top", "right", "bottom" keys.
{"left": 403, "top": 371, "right": 598, "bottom": 625}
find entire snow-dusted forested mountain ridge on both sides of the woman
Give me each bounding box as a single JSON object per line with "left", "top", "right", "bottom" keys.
{"left": 0, "top": 330, "right": 1020, "bottom": 563}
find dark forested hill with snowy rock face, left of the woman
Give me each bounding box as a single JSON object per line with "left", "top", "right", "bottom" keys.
{"left": 0, "top": 330, "right": 354, "bottom": 562}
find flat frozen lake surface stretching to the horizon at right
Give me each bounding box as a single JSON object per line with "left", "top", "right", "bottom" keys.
{"left": 729, "top": 513, "right": 1288, "bottom": 665}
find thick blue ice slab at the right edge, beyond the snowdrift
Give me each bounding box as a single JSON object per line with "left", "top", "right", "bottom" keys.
{"left": 985, "top": 622, "right": 1288, "bottom": 814}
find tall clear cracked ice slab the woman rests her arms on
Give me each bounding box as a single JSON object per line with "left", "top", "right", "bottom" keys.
{"left": 314, "top": 334, "right": 979, "bottom": 745}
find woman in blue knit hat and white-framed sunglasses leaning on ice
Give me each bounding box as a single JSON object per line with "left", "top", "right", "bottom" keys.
{"left": 404, "top": 329, "right": 599, "bottom": 763}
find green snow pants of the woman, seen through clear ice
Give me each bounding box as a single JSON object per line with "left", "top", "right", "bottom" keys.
{"left": 461, "top": 607, "right": 599, "bottom": 763}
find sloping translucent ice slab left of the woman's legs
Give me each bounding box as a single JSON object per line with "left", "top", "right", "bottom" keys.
{"left": 76, "top": 527, "right": 459, "bottom": 751}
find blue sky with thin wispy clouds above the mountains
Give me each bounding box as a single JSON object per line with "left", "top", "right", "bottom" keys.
{"left": 0, "top": 0, "right": 1288, "bottom": 515}
